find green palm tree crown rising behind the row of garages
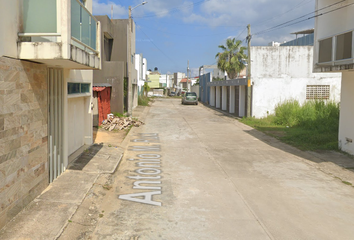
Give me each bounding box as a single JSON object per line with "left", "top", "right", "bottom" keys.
{"left": 215, "top": 38, "right": 247, "bottom": 79}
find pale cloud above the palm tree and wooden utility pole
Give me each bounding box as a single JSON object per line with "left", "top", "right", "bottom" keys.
{"left": 183, "top": 0, "right": 314, "bottom": 45}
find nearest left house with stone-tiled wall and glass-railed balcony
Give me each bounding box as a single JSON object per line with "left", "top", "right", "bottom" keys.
{"left": 0, "top": 0, "right": 101, "bottom": 227}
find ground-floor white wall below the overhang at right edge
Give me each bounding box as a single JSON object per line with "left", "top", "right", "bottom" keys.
{"left": 338, "top": 72, "right": 354, "bottom": 155}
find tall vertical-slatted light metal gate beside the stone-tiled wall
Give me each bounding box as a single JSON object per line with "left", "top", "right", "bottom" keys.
{"left": 48, "top": 68, "right": 64, "bottom": 182}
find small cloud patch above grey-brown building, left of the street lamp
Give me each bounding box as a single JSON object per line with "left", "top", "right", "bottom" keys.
{"left": 92, "top": 0, "right": 128, "bottom": 19}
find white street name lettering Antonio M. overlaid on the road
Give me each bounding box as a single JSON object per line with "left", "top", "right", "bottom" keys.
{"left": 119, "top": 133, "right": 162, "bottom": 206}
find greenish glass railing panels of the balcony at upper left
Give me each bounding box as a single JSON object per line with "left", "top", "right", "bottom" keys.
{"left": 19, "top": 0, "right": 98, "bottom": 54}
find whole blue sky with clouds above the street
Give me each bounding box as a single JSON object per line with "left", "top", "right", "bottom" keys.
{"left": 93, "top": 0, "right": 315, "bottom": 76}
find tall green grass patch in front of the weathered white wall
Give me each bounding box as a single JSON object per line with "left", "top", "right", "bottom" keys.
{"left": 240, "top": 100, "right": 339, "bottom": 150}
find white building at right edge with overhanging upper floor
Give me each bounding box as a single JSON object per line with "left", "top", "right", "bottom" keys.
{"left": 314, "top": 0, "right": 354, "bottom": 154}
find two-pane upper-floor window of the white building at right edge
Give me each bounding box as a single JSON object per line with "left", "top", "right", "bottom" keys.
{"left": 318, "top": 31, "right": 354, "bottom": 66}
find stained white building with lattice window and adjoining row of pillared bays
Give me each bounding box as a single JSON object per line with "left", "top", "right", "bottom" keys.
{"left": 206, "top": 46, "right": 341, "bottom": 118}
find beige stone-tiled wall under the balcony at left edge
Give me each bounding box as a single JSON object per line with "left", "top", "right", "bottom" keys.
{"left": 0, "top": 57, "right": 49, "bottom": 228}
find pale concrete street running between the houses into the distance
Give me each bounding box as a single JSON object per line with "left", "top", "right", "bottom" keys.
{"left": 59, "top": 98, "right": 354, "bottom": 240}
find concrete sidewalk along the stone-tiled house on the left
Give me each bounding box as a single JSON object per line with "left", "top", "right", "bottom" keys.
{"left": 0, "top": 106, "right": 149, "bottom": 240}
